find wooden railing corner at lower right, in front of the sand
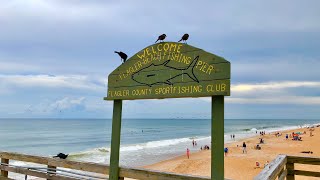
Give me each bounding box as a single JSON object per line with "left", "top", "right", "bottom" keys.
{"left": 255, "top": 155, "right": 320, "bottom": 180}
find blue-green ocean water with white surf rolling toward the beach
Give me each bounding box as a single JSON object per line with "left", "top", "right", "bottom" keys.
{"left": 0, "top": 119, "right": 320, "bottom": 167}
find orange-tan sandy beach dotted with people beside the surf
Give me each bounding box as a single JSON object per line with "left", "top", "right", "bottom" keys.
{"left": 144, "top": 127, "right": 320, "bottom": 180}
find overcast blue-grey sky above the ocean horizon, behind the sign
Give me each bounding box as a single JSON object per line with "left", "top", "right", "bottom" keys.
{"left": 0, "top": 0, "right": 320, "bottom": 119}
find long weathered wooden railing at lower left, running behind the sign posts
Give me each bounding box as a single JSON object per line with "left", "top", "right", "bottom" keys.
{"left": 0, "top": 152, "right": 210, "bottom": 180}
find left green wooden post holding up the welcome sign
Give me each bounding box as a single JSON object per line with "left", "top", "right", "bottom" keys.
{"left": 109, "top": 100, "right": 122, "bottom": 180}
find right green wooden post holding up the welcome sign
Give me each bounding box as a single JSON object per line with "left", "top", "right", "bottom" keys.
{"left": 211, "top": 96, "right": 224, "bottom": 180}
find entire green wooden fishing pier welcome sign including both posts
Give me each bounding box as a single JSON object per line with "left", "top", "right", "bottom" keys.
{"left": 104, "top": 42, "right": 230, "bottom": 180}
